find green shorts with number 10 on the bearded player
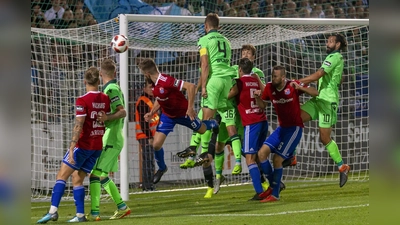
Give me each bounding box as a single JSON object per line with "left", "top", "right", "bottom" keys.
{"left": 301, "top": 97, "right": 338, "bottom": 128}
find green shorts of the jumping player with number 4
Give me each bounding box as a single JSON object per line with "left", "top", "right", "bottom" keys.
{"left": 201, "top": 77, "right": 232, "bottom": 110}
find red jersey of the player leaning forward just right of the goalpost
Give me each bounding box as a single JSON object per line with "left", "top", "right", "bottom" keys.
{"left": 153, "top": 73, "right": 188, "bottom": 118}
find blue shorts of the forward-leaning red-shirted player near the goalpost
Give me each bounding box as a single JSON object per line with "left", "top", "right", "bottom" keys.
{"left": 156, "top": 114, "right": 201, "bottom": 136}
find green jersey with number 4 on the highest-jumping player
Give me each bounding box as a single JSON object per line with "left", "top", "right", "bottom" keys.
{"left": 197, "top": 30, "right": 235, "bottom": 78}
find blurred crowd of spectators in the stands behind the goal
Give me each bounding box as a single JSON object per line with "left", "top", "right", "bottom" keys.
{"left": 31, "top": 0, "right": 369, "bottom": 29}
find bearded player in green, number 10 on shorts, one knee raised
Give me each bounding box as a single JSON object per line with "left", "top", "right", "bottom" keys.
{"left": 299, "top": 34, "right": 350, "bottom": 187}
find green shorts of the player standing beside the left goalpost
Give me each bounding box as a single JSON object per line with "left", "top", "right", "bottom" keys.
{"left": 92, "top": 145, "right": 122, "bottom": 176}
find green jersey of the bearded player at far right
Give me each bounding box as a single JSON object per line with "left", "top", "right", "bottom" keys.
{"left": 317, "top": 51, "right": 344, "bottom": 103}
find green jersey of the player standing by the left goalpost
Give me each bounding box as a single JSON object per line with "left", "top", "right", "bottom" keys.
{"left": 103, "top": 80, "right": 125, "bottom": 146}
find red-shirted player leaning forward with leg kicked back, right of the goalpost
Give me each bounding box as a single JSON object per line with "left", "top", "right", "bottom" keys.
{"left": 139, "top": 59, "right": 219, "bottom": 184}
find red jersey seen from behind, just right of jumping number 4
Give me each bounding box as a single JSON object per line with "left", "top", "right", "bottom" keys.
{"left": 236, "top": 75, "right": 267, "bottom": 126}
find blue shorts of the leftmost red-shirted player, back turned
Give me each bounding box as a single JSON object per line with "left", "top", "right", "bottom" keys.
{"left": 63, "top": 148, "right": 101, "bottom": 173}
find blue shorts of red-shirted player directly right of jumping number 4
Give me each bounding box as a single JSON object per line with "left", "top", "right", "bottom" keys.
{"left": 242, "top": 121, "right": 268, "bottom": 154}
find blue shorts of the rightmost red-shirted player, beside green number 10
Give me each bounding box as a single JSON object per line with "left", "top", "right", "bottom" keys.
{"left": 264, "top": 126, "right": 303, "bottom": 159}
